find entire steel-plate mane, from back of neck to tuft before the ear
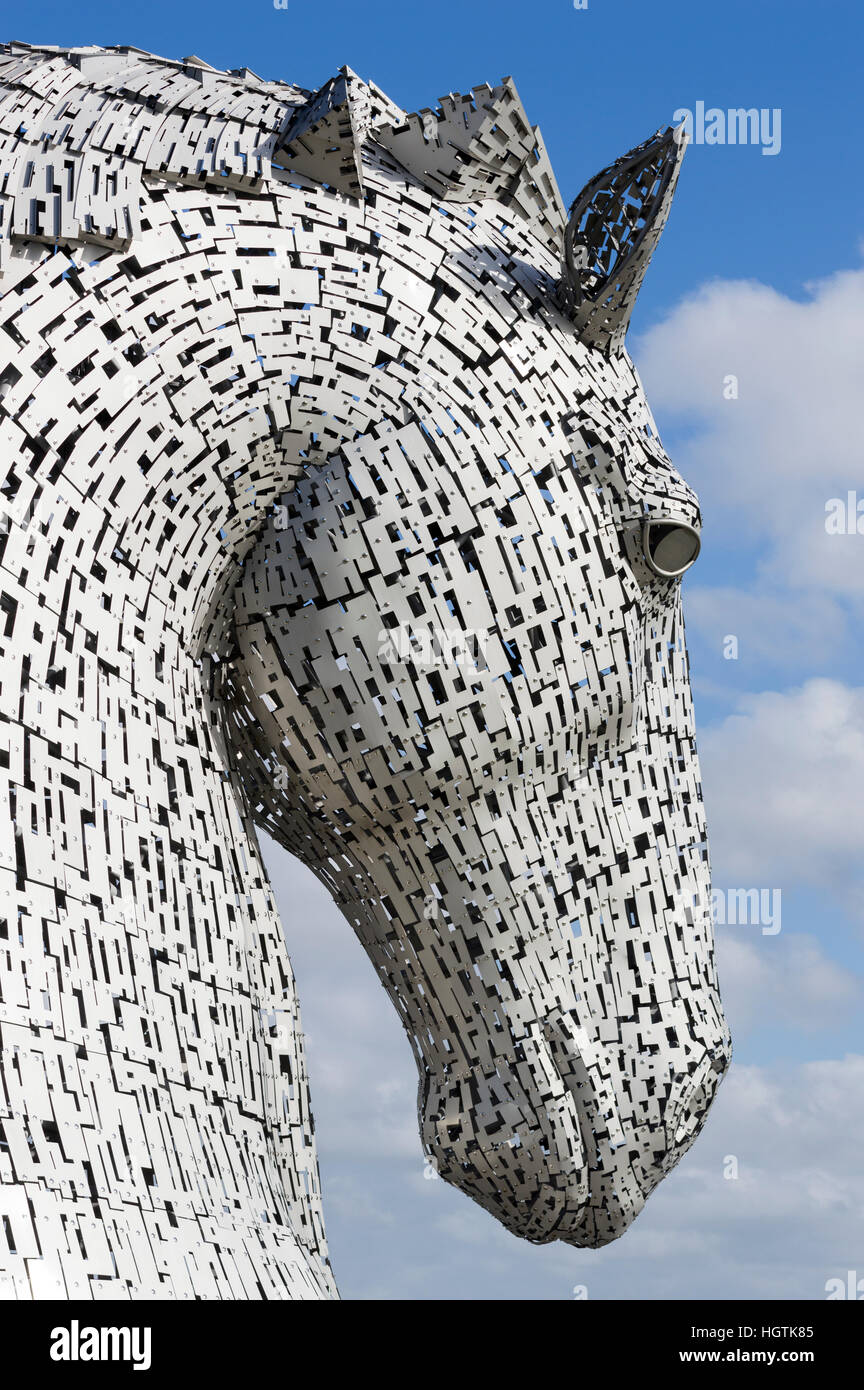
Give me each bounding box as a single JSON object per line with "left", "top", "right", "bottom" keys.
{"left": 0, "top": 43, "right": 575, "bottom": 271}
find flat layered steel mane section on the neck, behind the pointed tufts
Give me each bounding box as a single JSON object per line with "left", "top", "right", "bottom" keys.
{"left": 0, "top": 43, "right": 311, "bottom": 267}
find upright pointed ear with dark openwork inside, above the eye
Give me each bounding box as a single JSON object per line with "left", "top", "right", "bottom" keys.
{"left": 558, "top": 125, "right": 686, "bottom": 353}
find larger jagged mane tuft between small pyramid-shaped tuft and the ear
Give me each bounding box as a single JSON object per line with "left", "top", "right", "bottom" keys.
{"left": 371, "top": 78, "right": 567, "bottom": 249}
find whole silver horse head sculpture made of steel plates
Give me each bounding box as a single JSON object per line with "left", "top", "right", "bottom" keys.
{"left": 0, "top": 43, "right": 729, "bottom": 1298}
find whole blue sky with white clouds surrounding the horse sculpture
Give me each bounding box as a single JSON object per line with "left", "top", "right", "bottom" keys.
{"left": 15, "top": 0, "right": 864, "bottom": 1300}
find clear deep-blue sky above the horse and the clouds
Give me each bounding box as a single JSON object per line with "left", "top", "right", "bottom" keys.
{"left": 23, "top": 0, "right": 863, "bottom": 304}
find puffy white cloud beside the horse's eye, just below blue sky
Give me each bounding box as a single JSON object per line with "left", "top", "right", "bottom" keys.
{"left": 635, "top": 270, "right": 864, "bottom": 598}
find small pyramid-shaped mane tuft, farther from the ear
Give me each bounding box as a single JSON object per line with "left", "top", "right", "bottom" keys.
{"left": 274, "top": 67, "right": 404, "bottom": 197}
